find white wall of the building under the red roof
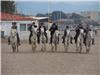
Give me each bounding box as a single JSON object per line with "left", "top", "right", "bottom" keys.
{"left": 0, "top": 21, "right": 37, "bottom": 40}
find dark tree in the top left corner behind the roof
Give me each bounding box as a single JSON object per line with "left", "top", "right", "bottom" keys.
{"left": 1, "top": 1, "right": 16, "bottom": 14}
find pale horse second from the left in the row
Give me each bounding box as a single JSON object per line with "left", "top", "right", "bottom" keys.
{"left": 31, "top": 26, "right": 37, "bottom": 52}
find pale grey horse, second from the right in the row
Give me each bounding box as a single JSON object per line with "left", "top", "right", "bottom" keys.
{"left": 76, "top": 29, "right": 84, "bottom": 53}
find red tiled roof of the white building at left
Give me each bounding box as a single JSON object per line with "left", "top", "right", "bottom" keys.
{"left": 0, "top": 13, "right": 33, "bottom": 21}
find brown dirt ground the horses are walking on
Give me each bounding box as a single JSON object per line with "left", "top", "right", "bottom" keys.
{"left": 1, "top": 30, "right": 100, "bottom": 75}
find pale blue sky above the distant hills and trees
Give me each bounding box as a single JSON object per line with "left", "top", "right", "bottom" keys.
{"left": 15, "top": 1, "right": 100, "bottom": 15}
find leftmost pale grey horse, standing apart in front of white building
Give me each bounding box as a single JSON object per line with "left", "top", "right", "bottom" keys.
{"left": 10, "top": 29, "right": 19, "bottom": 52}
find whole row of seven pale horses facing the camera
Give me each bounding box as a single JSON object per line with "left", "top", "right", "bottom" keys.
{"left": 10, "top": 28, "right": 96, "bottom": 53}
